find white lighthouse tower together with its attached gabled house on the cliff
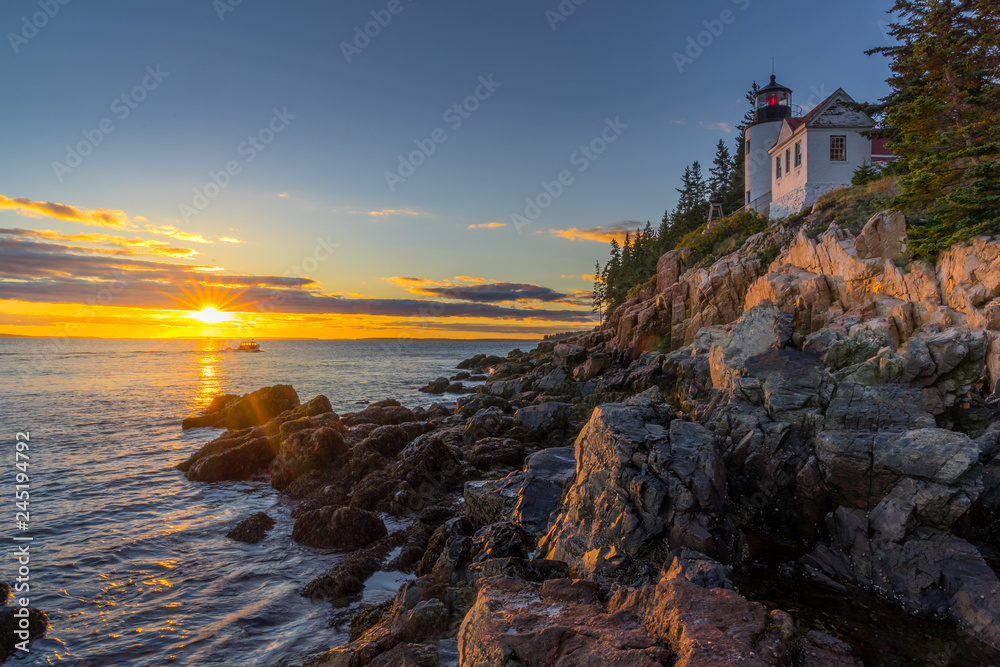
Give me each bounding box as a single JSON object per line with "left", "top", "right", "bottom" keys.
{"left": 745, "top": 76, "right": 893, "bottom": 218}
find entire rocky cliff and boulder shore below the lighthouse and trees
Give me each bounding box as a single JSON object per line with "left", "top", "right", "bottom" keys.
{"left": 179, "top": 210, "right": 1000, "bottom": 667}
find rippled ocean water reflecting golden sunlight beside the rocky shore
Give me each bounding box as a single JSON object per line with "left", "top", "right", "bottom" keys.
{"left": 0, "top": 338, "right": 535, "bottom": 666}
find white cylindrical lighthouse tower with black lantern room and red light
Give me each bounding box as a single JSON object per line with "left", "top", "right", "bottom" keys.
{"left": 744, "top": 74, "right": 792, "bottom": 211}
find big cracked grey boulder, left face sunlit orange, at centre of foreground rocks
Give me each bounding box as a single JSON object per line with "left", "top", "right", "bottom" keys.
{"left": 541, "top": 404, "right": 726, "bottom": 572}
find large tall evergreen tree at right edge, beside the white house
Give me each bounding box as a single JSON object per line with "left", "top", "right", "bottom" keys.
{"left": 866, "top": 0, "right": 1000, "bottom": 257}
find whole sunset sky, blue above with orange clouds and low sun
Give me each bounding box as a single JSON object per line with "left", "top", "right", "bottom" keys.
{"left": 0, "top": 0, "right": 892, "bottom": 338}
